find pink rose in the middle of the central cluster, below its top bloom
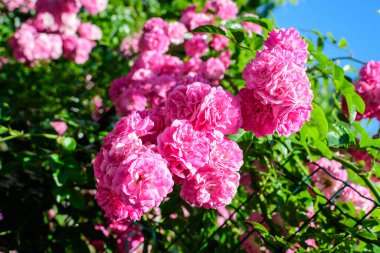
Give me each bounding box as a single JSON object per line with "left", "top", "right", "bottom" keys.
{"left": 157, "top": 120, "right": 210, "bottom": 182}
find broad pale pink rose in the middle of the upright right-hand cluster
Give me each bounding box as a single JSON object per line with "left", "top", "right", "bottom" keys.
{"left": 243, "top": 48, "right": 313, "bottom": 106}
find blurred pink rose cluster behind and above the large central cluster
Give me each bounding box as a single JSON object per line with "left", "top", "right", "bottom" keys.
{"left": 114, "top": 0, "right": 257, "bottom": 116}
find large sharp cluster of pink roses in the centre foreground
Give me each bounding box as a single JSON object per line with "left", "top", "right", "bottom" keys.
{"left": 94, "top": 78, "right": 243, "bottom": 220}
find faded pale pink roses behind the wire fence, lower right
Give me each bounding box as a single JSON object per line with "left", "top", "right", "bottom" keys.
{"left": 309, "top": 157, "right": 374, "bottom": 212}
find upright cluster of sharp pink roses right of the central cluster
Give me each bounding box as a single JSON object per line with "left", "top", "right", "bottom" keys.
{"left": 239, "top": 28, "right": 313, "bottom": 136}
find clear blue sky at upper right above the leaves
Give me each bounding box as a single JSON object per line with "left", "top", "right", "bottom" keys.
{"left": 273, "top": 0, "right": 380, "bottom": 134}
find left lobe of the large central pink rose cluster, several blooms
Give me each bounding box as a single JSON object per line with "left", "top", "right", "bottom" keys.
{"left": 94, "top": 113, "right": 174, "bottom": 220}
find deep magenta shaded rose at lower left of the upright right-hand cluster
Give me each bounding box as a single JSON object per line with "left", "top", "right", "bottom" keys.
{"left": 238, "top": 88, "right": 275, "bottom": 137}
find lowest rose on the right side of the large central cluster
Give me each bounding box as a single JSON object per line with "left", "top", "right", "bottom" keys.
{"left": 181, "top": 166, "right": 240, "bottom": 209}
